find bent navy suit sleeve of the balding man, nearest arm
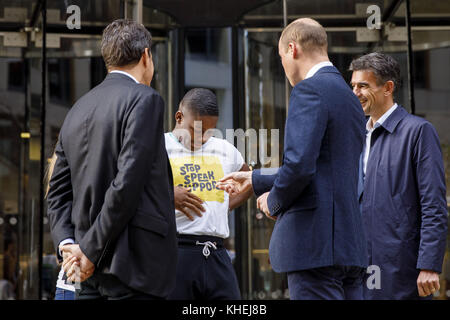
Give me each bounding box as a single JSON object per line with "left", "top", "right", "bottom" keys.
{"left": 267, "top": 83, "right": 328, "bottom": 216}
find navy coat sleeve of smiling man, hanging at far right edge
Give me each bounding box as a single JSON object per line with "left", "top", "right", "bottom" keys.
{"left": 414, "top": 123, "right": 447, "bottom": 273}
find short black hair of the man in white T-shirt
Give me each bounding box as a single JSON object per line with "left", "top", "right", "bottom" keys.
{"left": 181, "top": 88, "right": 219, "bottom": 117}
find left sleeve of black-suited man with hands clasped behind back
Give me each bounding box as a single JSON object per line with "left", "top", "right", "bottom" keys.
{"left": 47, "top": 138, "right": 75, "bottom": 260}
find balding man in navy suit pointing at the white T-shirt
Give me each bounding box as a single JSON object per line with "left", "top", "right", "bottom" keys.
{"left": 220, "top": 19, "right": 367, "bottom": 299}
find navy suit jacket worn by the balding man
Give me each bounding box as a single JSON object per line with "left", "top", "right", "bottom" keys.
{"left": 253, "top": 66, "right": 367, "bottom": 272}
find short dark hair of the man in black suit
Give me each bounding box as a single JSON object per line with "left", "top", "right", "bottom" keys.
{"left": 102, "top": 19, "right": 152, "bottom": 68}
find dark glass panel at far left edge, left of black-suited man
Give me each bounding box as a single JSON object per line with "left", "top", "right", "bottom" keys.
{"left": 0, "top": 33, "right": 46, "bottom": 299}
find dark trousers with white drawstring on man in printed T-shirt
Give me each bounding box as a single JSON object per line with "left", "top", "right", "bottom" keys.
{"left": 168, "top": 235, "right": 241, "bottom": 300}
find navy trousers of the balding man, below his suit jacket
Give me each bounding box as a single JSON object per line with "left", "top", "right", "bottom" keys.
{"left": 288, "top": 266, "right": 364, "bottom": 300}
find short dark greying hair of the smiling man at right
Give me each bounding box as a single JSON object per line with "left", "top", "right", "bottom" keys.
{"left": 349, "top": 52, "right": 402, "bottom": 92}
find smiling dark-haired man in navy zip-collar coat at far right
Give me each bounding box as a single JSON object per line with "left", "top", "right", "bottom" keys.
{"left": 350, "top": 52, "right": 447, "bottom": 300}
